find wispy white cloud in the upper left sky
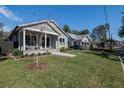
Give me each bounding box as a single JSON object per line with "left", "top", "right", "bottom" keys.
{"left": 0, "top": 6, "right": 23, "bottom": 22}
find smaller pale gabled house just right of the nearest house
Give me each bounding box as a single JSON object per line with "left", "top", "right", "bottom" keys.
{"left": 67, "top": 33, "right": 90, "bottom": 49}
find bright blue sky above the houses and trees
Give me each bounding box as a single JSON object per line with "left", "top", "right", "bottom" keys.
{"left": 0, "top": 5, "right": 124, "bottom": 40}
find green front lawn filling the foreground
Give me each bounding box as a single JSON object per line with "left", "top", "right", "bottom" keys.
{"left": 0, "top": 50, "right": 124, "bottom": 87}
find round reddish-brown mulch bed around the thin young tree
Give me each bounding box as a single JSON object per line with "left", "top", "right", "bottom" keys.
{"left": 26, "top": 63, "right": 48, "bottom": 70}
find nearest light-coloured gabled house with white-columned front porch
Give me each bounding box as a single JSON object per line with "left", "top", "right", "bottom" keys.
{"left": 9, "top": 20, "right": 69, "bottom": 55}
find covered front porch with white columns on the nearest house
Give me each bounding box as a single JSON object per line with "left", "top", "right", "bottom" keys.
{"left": 18, "top": 29, "right": 59, "bottom": 55}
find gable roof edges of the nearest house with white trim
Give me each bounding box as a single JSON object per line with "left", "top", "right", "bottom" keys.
{"left": 9, "top": 20, "right": 68, "bottom": 38}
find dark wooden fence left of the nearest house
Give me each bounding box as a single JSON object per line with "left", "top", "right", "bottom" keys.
{"left": 0, "top": 41, "right": 13, "bottom": 54}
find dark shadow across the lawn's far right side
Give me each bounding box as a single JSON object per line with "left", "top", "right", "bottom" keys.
{"left": 85, "top": 51, "right": 119, "bottom": 61}
